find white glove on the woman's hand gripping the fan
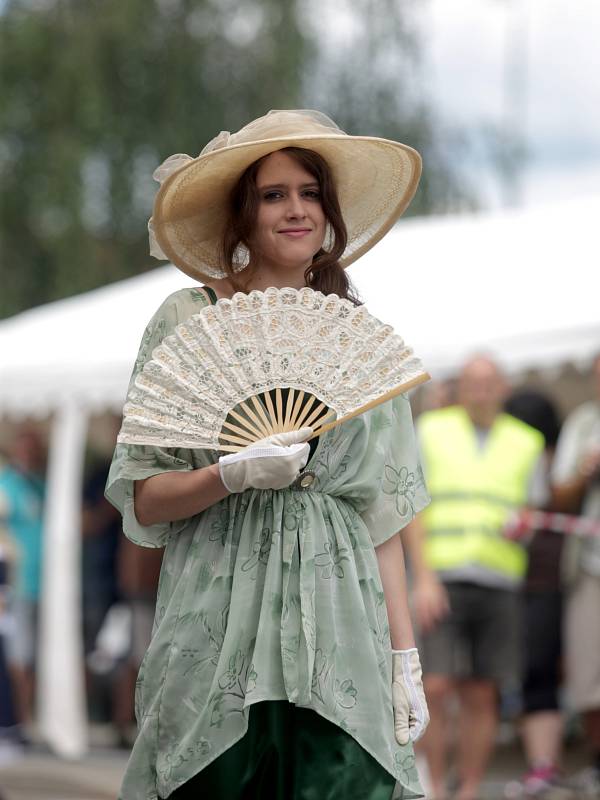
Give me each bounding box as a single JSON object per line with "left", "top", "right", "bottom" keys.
{"left": 219, "top": 428, "right": 313, "bottom": 492}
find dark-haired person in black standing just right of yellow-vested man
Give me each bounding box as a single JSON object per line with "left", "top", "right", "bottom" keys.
{"left": 505, "top": 390, "right": 564, "bottom": 798}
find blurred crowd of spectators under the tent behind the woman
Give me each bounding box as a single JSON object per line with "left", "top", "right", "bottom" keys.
{"left": 0, "top": 356, "right": 600, "bottom": 800}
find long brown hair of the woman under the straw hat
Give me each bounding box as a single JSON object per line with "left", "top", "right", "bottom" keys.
{"left": 221, "top": 147, "right": 360, "bottom": 305}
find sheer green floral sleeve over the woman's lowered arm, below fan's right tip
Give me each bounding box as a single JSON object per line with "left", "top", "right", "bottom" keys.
{"left": 361, "top": 395, "right": 430, "bottom": 547}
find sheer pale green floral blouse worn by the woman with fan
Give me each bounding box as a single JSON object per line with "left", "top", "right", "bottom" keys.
{"left": 106, "top": 289, "right": 429, "bottom": 800}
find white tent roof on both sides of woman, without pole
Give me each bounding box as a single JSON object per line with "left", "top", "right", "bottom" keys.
{"left": 0, "top": 196, "right": 600, "bottom": 415}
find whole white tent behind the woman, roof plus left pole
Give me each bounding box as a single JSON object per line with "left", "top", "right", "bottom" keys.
{"left": 0, "top": 196, "right": 600, "bottom": 756}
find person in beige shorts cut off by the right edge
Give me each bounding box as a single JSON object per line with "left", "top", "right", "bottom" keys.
{"left": 552, "top": 355, "right": 600, "bottom": 797}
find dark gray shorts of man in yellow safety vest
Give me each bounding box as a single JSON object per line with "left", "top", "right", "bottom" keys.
{"left": 420, "top": 581, "right": 521, "bottom": 688}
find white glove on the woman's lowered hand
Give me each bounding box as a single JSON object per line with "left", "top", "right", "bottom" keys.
{"left": 392, "top": 647, "right": 429, "bottom": 744}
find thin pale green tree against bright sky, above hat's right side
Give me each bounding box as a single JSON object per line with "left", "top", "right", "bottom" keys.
{"left": 308, "top": 0, "right": 475, "bottom": 216}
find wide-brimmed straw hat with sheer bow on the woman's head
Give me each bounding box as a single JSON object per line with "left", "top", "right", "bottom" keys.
{"left": 148, "top": 110, "right": 421, "bottom": 280}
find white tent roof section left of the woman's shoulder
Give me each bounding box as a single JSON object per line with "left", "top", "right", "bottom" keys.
{"left": 0, "top": 266, "right": 192, "bottom": 417}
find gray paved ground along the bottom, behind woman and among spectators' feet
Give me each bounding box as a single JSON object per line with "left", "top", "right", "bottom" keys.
{"left": 0, "top": 744, "right": 584, "bottom": 800}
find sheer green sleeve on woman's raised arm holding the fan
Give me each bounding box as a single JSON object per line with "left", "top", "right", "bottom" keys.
{"left": 105, "top": 289, "right": 208, "bottom": 547}
